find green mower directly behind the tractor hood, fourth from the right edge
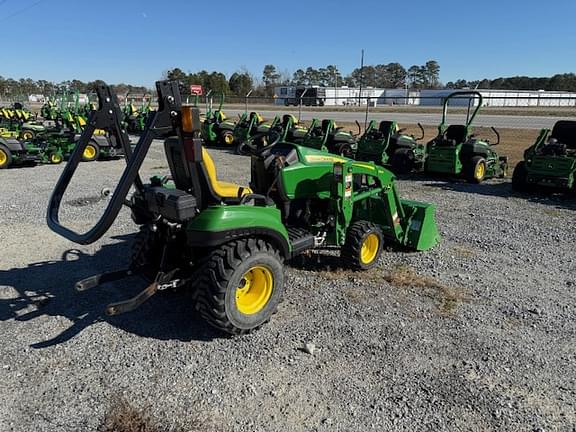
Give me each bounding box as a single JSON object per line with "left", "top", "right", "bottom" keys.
{"left": 301, "top": 119, "right": 356, "bottom": 157}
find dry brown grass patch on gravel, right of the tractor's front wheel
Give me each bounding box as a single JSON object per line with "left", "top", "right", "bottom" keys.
{"left": 384, "top": 266, "right": 471, "bottom": 315}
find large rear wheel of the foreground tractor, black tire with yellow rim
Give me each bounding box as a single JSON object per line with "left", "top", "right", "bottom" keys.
{"left": 195, "top": 238, "right": 284, "bottom": 335}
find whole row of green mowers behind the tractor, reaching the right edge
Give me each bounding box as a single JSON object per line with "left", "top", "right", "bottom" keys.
{"left": 202, "top": 91, "right": 576, "bottom": 192}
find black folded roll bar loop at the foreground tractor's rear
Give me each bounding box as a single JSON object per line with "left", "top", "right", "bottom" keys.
{"left": 46, "top": 81, "right": 182, "bottom": 245}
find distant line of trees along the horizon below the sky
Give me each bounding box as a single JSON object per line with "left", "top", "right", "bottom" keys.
{"left": 0, "top": 64, "right": 576, "bottom": 98}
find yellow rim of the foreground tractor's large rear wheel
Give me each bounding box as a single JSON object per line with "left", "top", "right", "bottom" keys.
{"left": 236, "top": 266, "right": 274, "bottom": 315}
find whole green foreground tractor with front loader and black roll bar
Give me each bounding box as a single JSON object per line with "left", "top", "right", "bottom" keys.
{"left": 47, "top": 81, "right": 439, "bottom": 334}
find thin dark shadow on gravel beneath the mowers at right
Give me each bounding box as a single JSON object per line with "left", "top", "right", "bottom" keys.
{"left": 425, "top": 181, "right": 576, "bottom": 209}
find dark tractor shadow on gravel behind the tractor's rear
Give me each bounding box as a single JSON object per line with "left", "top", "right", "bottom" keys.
{"left": 0, "top": 236, "right": 222, "bottom": 348}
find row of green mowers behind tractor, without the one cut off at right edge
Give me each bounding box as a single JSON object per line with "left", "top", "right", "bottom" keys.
{"left": 202, "top": 91, "right": 508, "bottom": 183}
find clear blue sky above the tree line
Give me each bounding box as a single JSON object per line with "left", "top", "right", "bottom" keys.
{"left": 0, "top": 0, "right": 576, "bottom": 86}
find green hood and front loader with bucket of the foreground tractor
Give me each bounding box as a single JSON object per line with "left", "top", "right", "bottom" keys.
{"left": 280, "top": 145, "right": 440, "bottom": 250}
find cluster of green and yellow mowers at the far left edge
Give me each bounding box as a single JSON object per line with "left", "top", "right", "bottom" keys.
{"left": 0, "top": 94, "right": 122, "bottom": 169}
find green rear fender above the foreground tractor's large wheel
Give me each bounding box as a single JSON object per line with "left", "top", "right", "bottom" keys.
{"left": 186, "top": 205, "right": 291, "bottom": 258}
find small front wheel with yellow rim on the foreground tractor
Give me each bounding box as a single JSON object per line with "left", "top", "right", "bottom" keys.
{"left": 340, "top": 221, "right": 384, "bottom": 270}
